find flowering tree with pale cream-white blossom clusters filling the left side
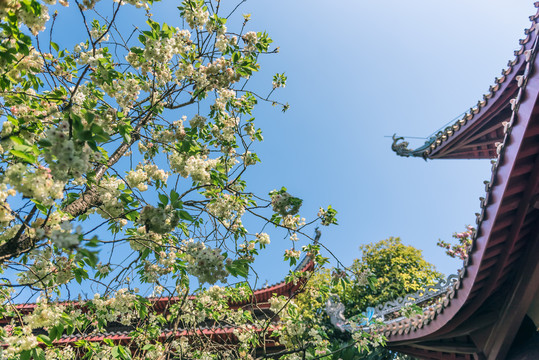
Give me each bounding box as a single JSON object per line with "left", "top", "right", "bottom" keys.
{"left": 0, "top": 0, "right": 376, "bottom": 359}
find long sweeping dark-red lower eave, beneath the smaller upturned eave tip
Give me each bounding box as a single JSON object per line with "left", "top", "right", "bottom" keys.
{"left": 384, "top": 31, "right": 539, "bottom": 348}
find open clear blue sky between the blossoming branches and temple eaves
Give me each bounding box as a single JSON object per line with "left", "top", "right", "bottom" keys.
{"left": 197, "top": 0, "right": 535, "bottom": 283}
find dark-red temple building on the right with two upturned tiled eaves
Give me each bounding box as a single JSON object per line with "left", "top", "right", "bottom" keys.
{"left": 378, "top": 2, "right": 539, "bottom": 360}
